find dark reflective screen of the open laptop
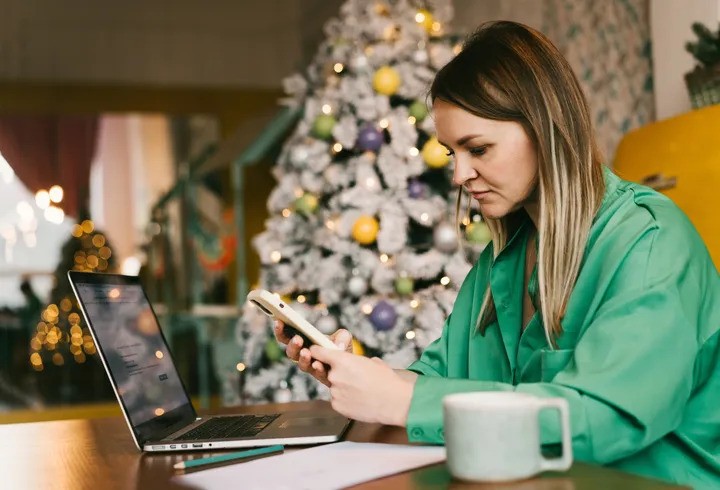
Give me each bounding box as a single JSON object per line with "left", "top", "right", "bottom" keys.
{"left": 77, "top": 283, "right": 190, "bottom": 426}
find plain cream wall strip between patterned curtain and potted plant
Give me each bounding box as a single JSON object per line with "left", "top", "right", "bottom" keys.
{"left": 650, "top": 0, "right": 720, "bottom": 119}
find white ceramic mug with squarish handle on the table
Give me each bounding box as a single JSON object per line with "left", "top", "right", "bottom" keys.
{"left": 443, "top": 391, "right": 572, "bottom": 482}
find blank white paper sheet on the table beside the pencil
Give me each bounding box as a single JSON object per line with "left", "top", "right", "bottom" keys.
{"left": 173, "top": 441, "right": 445, "bottom": 490}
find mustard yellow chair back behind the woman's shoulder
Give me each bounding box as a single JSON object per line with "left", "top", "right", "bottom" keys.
{"left": 613, "top": 105, "right": 720, "bottom": 268}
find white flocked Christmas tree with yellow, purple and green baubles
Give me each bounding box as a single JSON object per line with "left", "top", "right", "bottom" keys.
{"left": 233, "top": 0, "right": 489, "bottom": 403}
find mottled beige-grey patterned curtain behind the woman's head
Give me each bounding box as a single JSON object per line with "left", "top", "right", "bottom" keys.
{"left": 542, "top": 0, "right": 655, "bottom": 164}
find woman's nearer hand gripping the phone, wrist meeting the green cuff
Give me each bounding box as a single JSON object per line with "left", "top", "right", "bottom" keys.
{"left": 310, "top": 345, "right": 415, "bottom": 427}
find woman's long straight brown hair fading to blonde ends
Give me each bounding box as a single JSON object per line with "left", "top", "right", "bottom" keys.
{"left": 430, "top": 21, "right": 605, "bottom": 347}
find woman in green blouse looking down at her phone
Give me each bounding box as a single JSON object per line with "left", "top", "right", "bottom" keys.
{"left": 276, "top": 22, "right": 720, "bottom": 488}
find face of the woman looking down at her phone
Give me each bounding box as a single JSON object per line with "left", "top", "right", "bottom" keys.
{"left": 433, "top": 99, "right": 538, "bottom": 219}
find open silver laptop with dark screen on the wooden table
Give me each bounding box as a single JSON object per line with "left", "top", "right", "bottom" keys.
{"left": 68, "top": 271, "right": 350, "bottom": 451}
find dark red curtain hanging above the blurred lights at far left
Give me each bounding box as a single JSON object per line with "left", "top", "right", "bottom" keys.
{"left": 0, "top": 116, "right": 97, "bottom": 217}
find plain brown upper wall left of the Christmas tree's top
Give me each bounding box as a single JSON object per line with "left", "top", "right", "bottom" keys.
{"left": 0, "top": 0, "right": 339, "bottom": 86}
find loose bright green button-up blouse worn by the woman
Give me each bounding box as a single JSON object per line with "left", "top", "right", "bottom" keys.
{"left": 407, "top": 170, "right": 720, "bottom": 488}
